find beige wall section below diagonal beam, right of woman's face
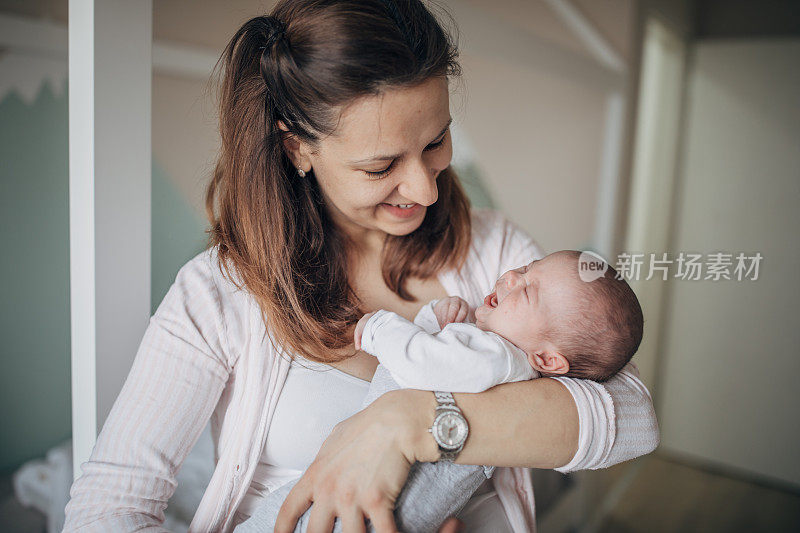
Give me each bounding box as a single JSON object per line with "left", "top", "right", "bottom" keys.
{"left": 456, "top": 49, "right": 604, "bottom": 251}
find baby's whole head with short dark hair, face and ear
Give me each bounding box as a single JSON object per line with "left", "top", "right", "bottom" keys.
{"left": 475, "top": 250, "right": 643, "bottom": 381}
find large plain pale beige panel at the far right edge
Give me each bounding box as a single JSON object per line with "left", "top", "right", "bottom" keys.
{"left": 659, "top": 39, "right": 800, "bottom": 485}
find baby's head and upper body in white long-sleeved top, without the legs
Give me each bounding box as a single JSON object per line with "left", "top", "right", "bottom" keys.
{"left": 354, "top": 250, "right": 643, "bottom": 392}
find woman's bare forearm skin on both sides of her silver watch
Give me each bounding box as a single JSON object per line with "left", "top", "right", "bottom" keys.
{"left": 398, "top": 378, "right": 579, "bottom": 468}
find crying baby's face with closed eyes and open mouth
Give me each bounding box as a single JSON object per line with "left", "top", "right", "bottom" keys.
{"left": 475, "top": 252, "right": 581, "bottom": 351}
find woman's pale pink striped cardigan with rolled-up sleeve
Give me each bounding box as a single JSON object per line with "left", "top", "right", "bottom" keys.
{"left": 64, "top": 209, "right": 658, "bottom": 532}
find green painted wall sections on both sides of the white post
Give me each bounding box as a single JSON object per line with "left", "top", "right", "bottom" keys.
{"left": 0, "top": 83, "right": 206, "bottom": 475}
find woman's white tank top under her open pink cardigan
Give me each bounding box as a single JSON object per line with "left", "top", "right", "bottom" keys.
{"left": 237, "top": 357, "right": 511, "bottom": 533}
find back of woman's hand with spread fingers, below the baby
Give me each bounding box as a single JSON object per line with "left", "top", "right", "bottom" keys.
{"left": 275, "top": 391, "right": 438, "bottom": 533}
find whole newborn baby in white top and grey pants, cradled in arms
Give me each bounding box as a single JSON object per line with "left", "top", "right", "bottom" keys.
{"left": 235, "top": 251, "right": 642, "bottom": 533}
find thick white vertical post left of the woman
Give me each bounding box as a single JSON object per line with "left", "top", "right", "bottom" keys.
{"left": 69, "top": 0, "right": 153, "bottom": 477}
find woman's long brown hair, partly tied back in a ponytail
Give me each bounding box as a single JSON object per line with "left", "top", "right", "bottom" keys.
{"left": 206, "top": 0, "right": 471, "bottom": 362}
